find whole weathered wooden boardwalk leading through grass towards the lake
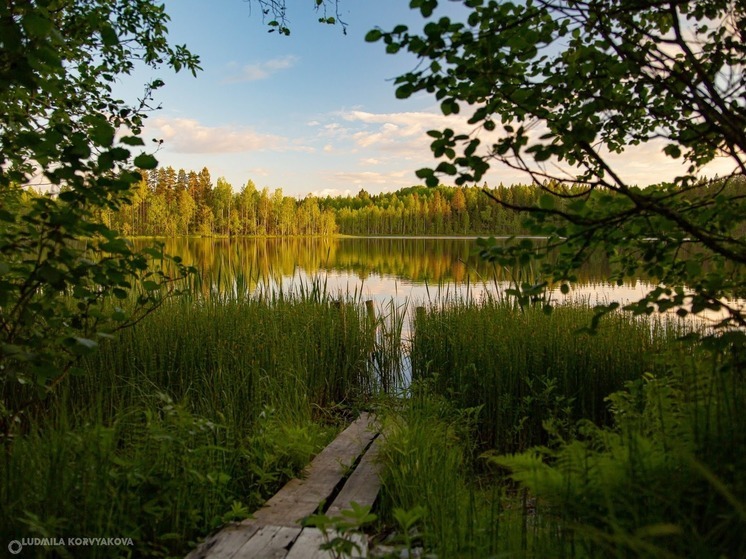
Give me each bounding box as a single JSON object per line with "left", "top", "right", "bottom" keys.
{"left": 187, "top": 413, "right": 380, "bottom": 559}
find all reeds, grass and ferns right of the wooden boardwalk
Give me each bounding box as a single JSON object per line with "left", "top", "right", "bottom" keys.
{"left": 374, "top": 302, "right": 746, "bottom": 558}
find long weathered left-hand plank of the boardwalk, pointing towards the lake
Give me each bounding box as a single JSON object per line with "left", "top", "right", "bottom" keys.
{"left": 254, "top": 413, "right": 376, "bottom": 526}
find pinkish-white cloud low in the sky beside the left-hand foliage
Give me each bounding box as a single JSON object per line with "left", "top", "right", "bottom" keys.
{"left": 145, "top": 118, "right": 313, "bottom": 153}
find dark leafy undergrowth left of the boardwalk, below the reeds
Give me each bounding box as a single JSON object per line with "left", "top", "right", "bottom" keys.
{"left": 0, "top": 393, "right": 329, "bottom": 557}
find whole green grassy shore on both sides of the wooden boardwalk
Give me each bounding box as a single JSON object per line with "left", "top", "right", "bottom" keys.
{"left": 0, "top": 296, "right": 746, "bottom": 558}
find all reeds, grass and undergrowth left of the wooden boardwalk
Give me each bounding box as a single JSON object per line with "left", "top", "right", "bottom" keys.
{"left": 0, "top": 291, "right": 381, "bottom": 557}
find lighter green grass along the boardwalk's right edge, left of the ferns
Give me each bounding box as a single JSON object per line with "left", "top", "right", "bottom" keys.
{"left": 379, "top": 388, "right": 556, "bottom": 557}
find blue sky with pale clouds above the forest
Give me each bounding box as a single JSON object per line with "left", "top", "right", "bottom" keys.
{"left": 122, "top": 0, "right": 732, "bottom": 198}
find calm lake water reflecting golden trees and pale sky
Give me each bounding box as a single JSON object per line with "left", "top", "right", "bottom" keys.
{"left": 138, "top": 237, "right": 648, "bottom": 306}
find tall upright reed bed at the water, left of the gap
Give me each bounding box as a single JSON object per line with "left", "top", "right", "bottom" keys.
{"left": 70, "top": 293, "right": 376, "bottom": 428}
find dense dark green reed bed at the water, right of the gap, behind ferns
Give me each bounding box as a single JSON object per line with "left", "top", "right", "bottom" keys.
{"left": 411, "top": 299, "right": 681, "bottom": 452}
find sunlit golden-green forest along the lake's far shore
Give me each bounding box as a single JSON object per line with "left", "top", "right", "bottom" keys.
{"left": 83, "top": 167, "right": 580, "bottom": 237}
